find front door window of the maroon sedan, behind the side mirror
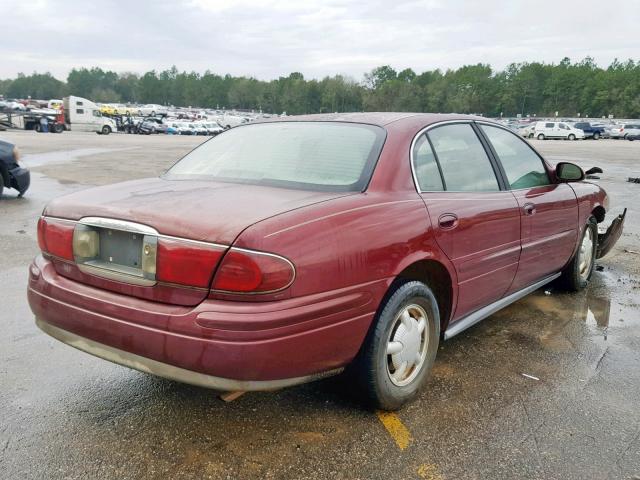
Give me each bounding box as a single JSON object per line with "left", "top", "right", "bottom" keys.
{"left": 480, "top": 125, "right": 550, "bottom": 190}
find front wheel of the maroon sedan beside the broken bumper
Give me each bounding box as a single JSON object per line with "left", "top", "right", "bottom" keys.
{"left": 560, "top": 216, "right": 598, "bottom": 292}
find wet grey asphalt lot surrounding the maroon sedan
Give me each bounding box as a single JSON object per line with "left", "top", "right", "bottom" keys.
{"left": 0, "top": 132, "right": 640, "bottom": 479}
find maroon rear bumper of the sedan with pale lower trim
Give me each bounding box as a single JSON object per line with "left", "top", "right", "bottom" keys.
{"left": 28, "top": 256, "right": 386, "bottom": 390}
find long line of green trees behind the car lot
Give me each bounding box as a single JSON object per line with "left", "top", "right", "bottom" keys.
{"left": 0, "top": 57, "right": 640, "bottom": 118}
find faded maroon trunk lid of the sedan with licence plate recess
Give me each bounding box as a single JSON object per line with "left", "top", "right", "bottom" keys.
{"left": 43, "top": 179, "right": 345, "bottom": 305}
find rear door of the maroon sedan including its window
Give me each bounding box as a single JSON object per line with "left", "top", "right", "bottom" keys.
{"left": 412, "top": 122, "right": 520, "bottom": 321}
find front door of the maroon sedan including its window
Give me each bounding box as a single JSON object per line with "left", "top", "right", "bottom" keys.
{"left": 480, "top": 124, "right": 578, "bottom": 293}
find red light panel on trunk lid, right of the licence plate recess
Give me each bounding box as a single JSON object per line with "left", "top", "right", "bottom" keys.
{"left": 156, "top": 238, "right": 226, "bottom": 288}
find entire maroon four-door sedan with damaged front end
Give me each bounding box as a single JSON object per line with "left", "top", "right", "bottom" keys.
{"left": 28, "top": 113, "right": 624, "bottom": 409}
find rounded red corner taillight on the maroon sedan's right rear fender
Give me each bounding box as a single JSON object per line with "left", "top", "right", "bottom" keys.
{"left": 212, "top": 248, "right": 295, "bottom": 293}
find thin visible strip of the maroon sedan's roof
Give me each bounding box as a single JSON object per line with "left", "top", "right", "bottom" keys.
{"left": 252, "top": 112, "right": 492, "bottom": 127}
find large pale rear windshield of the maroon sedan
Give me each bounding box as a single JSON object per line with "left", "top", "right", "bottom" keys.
{"left": 165, "top": 122, "right": 385, "bottom": 191}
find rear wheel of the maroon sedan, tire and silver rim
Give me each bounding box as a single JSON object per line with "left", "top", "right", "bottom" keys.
{"left": 351, "top": 281, "right": 440, "bottom": 410}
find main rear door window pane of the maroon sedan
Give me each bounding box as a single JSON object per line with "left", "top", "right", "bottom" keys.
{"left": 428, "top": 124, "right": 500, "bottom": 192}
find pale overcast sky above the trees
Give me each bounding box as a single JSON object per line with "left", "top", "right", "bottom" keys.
{"left": 0, "top": 0, "right": 640, "bottom": 80}
